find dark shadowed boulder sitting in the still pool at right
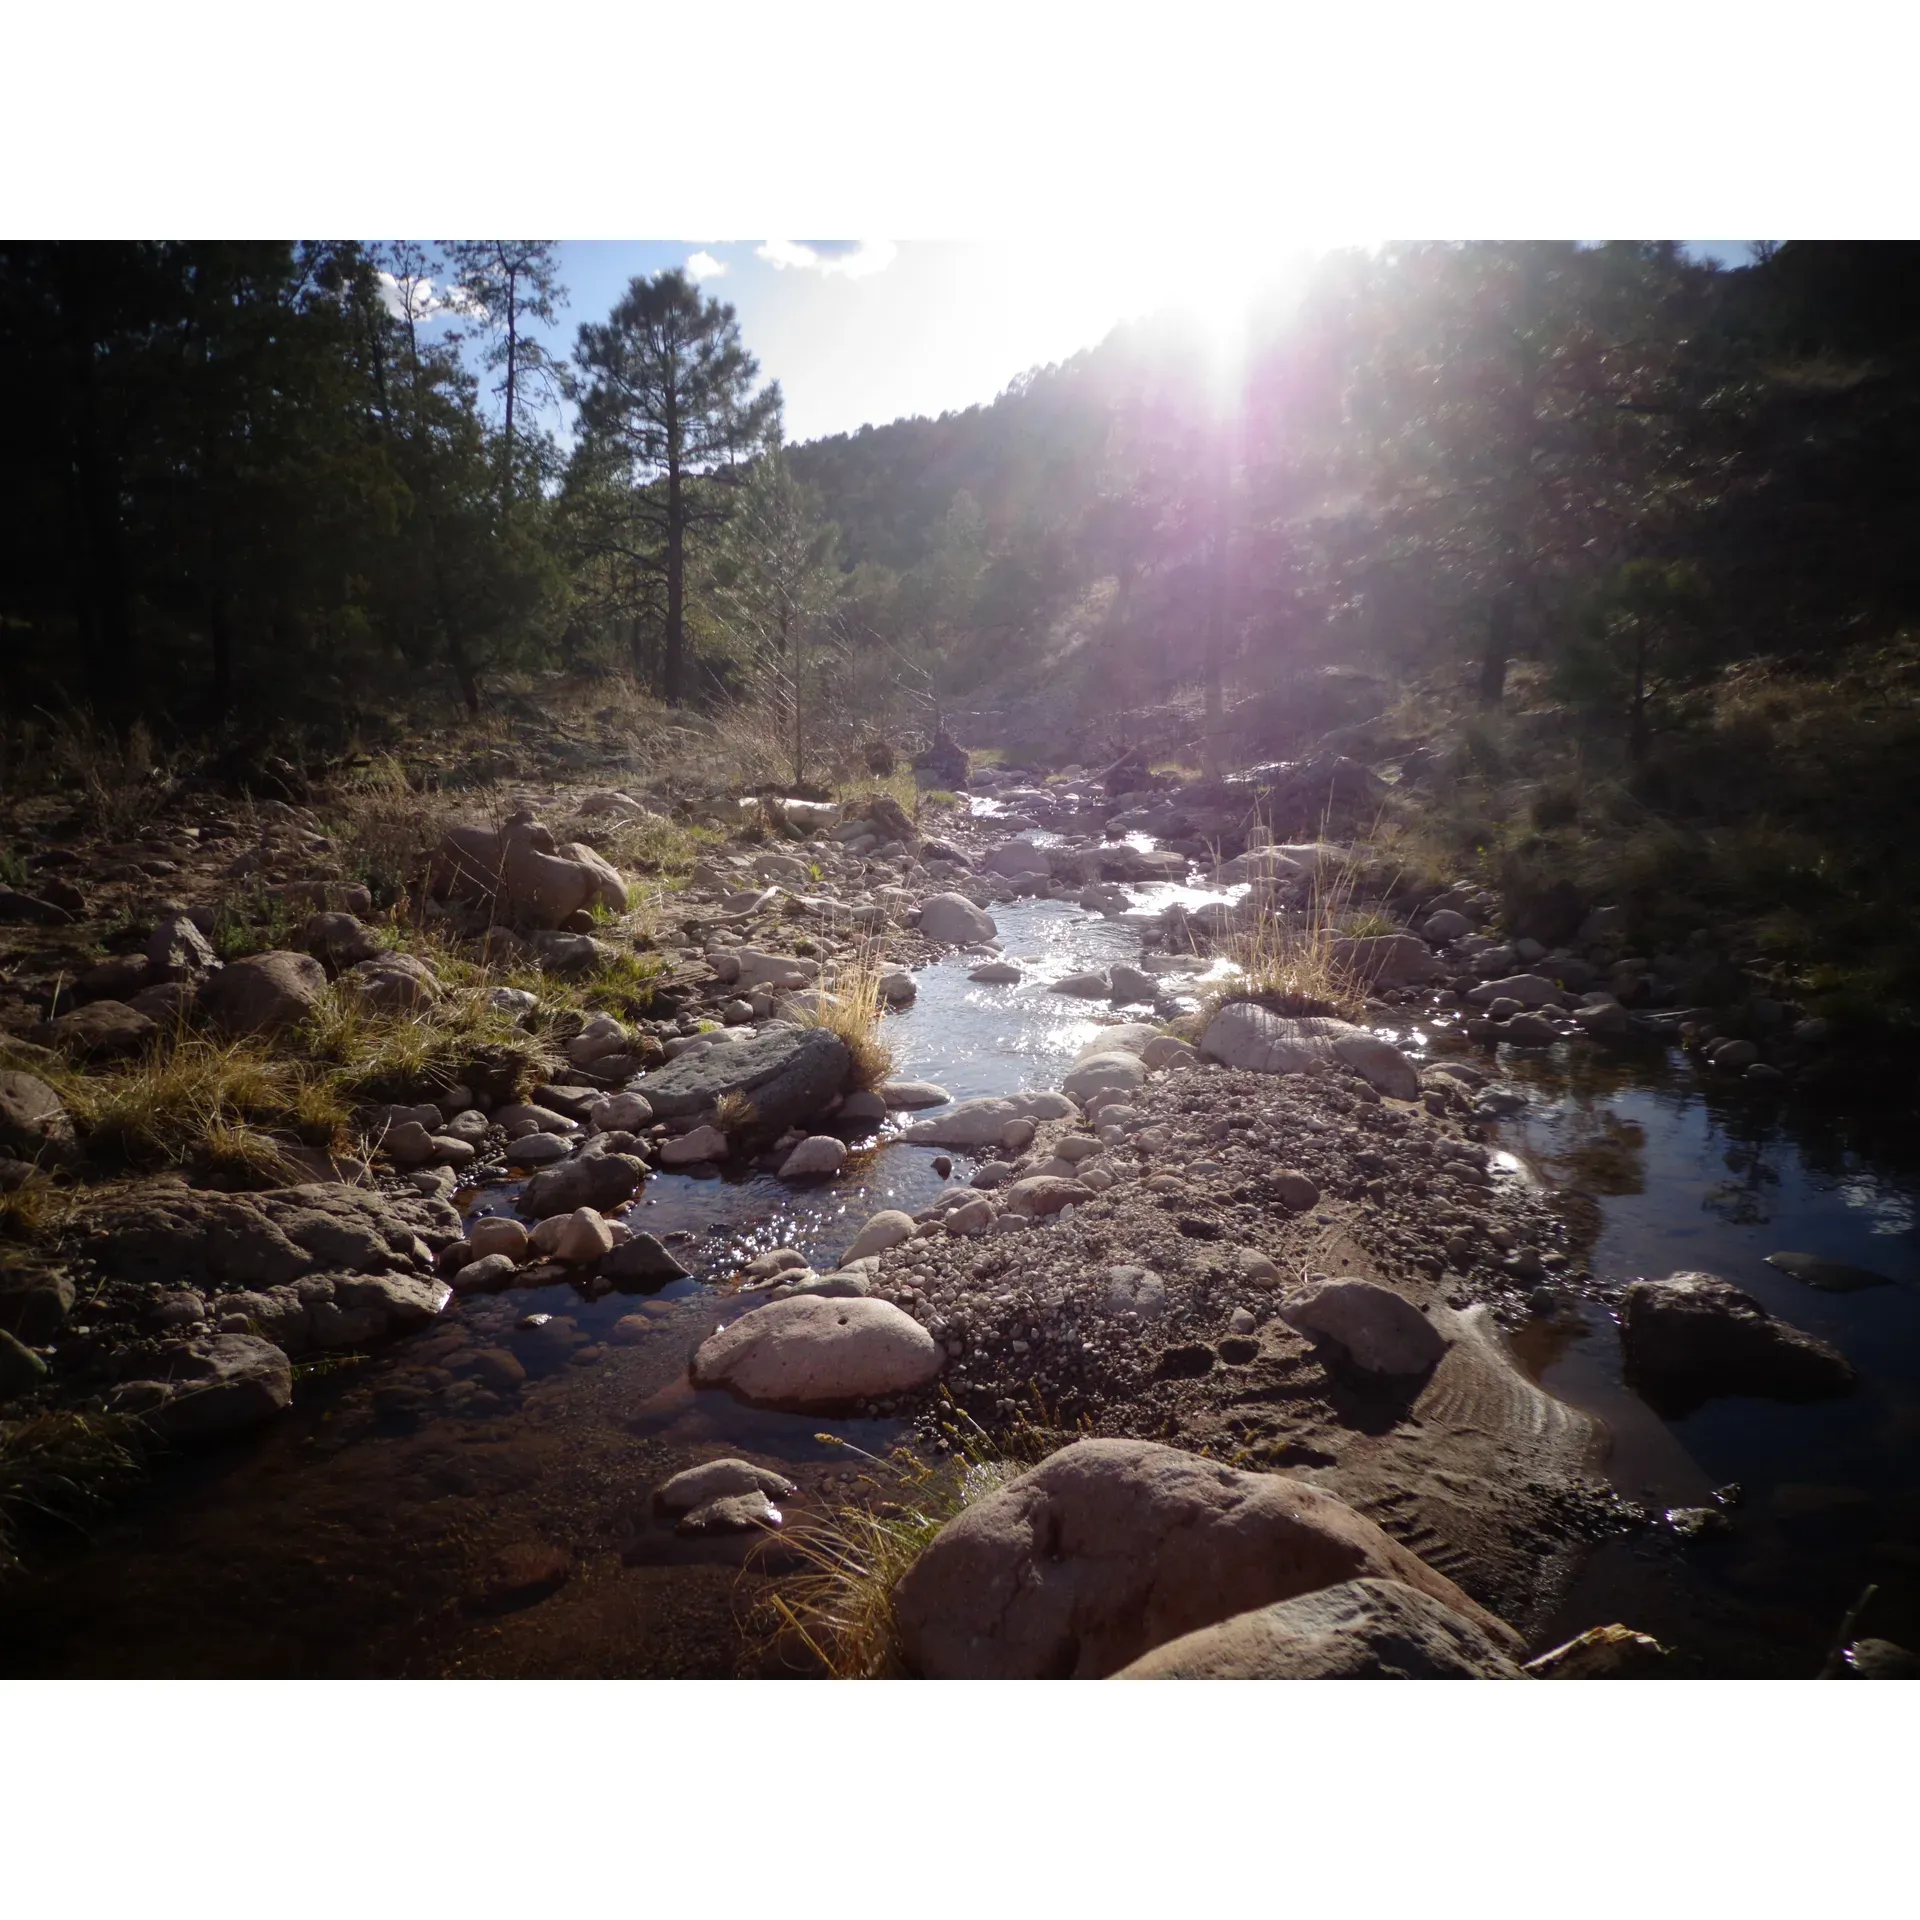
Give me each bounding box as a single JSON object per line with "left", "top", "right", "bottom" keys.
{"left": 1620, "top": 1273, "right": 1857, "bottom": 1415}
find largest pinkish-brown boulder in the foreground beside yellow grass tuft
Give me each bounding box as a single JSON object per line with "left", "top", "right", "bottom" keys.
{"left": 895, "top": 1440, "right": 1519, "bottom": 1680}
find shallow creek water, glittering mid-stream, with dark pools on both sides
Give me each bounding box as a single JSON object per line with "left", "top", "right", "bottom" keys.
{"left": 0, "top": 829, "right": 1920, "bottom": 1676}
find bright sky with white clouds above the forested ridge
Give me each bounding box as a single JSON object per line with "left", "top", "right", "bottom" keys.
{"left": 397, "top": 234, "right": 1747, "bottom": 442}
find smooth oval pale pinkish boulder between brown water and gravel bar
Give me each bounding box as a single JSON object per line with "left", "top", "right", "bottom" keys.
{"left": 693, "top": 1296, "right": 941, "bottom": 1409}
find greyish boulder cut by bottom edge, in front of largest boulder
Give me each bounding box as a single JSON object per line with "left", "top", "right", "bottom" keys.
{"left": 1114, "top": 1580, "right": 1524, "bottom": 1680}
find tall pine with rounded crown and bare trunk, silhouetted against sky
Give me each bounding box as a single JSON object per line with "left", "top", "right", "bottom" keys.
{"left": 574, "top": 269, "right": 780, "bottom": 707}
